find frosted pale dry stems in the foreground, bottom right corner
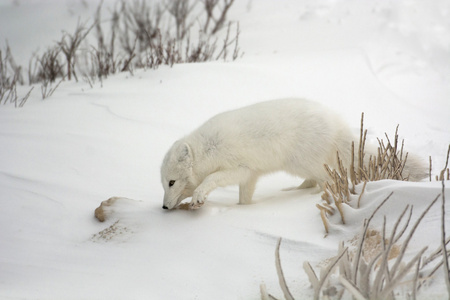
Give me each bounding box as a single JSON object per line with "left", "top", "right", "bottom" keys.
{"left": 260, "top": 189, "right": 450, "bottom": 299}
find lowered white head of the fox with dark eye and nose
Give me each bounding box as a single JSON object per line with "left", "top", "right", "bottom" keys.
{"left": 161, "top": 141, "right": 195, "bottom": 209}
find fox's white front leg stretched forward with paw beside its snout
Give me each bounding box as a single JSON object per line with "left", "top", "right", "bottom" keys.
{"left": 190, "top": 167, "right": 252, "bottom": 209}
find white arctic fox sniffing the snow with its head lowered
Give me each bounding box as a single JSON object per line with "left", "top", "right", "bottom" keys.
{"left": 161, "top": 99, "right": 426, "bottom": 209}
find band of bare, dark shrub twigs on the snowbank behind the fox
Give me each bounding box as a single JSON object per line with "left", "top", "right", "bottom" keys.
{"left": 0, "top": 0, "right": 242, "bottom": 107}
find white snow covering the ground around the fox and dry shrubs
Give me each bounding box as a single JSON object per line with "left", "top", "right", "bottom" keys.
{"left": 0, "top": 0, "right": 450, "bottom": 299}
